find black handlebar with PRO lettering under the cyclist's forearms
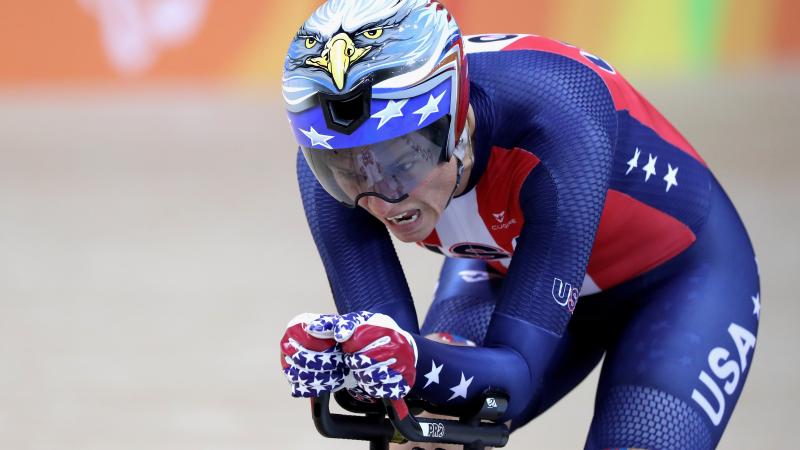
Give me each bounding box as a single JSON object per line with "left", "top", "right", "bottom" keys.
{"left": 311, "top": 391, "right": 509, "bottom": 450}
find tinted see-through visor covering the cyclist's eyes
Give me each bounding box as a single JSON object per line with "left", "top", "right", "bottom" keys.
{"left": 301, "top": 116, "right": 450, "bottom": 207}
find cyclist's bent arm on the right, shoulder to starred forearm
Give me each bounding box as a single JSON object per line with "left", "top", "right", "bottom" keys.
{"left": 415, "top": 59, "right": 617, "bottom": 418}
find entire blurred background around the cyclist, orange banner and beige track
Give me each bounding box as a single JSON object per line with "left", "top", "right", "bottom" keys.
{"left": 0, "top": 0, "right": 800, "bottom": 450}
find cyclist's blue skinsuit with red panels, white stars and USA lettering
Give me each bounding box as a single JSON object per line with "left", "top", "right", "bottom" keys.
{"left": 297, "top": 38, "right": 760, "bottom": 448}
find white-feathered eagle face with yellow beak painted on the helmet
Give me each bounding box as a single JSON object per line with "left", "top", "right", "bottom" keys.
{"left": 283, "top": 0, "right": 461, "bottom": 110}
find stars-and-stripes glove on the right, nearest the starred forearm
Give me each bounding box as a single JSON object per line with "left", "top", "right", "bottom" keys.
{"left": 334, "top": 311, "right": 417, "bottom": 400}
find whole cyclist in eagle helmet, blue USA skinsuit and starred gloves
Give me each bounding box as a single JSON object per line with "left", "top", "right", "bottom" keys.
{"left": 281, "top": 0, "right": 760, "bottom": 449}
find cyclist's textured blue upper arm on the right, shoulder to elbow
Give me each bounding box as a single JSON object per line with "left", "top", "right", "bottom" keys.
{"left": 485, "top": 57, "right": 617, "bottom": 345}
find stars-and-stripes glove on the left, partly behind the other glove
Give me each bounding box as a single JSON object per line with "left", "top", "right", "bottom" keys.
{"left": 281, "top": 314, "right": 348, "bottom": 397}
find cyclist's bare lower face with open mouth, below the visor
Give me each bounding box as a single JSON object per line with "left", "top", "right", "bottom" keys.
{"left": 358, "top": 158, "right": 457, "bottom": 242}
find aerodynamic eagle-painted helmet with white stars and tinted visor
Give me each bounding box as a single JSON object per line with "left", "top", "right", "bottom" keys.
{"left": 283, "top": 0, "right": 469, "bottom": 207}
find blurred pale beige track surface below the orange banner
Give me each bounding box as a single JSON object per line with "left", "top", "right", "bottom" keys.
{"left": 0, "top": 72, "right": 800, "bottom": 450}
